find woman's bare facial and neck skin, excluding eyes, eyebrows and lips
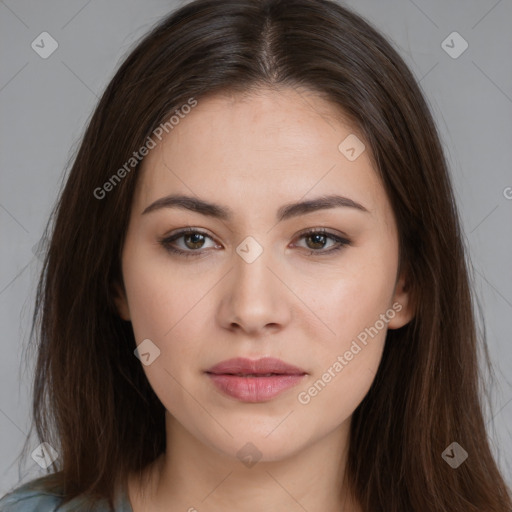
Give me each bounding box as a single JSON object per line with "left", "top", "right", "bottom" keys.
{"left": 117, "top": 89, "right": 411, "bottom": 512}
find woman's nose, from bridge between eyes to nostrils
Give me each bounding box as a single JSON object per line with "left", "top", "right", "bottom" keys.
{"left": 218, "top": 243, "right": 293, "bottom": 336}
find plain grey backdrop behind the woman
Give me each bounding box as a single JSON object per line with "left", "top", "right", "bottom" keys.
{"left": 0, "top": 0, "right": 512, "bottom": 495}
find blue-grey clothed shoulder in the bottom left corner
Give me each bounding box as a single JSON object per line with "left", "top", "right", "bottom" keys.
{"left": 0, "top": 479, "right": 61, "bottom": 512}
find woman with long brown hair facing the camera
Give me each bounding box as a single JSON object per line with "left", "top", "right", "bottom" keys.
{"left": 0, "top": 0, "right": 512, "bottom": 512}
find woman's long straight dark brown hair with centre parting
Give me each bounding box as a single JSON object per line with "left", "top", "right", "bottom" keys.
{"left": 12, "top": 0, "right": 512, "bottom": 512}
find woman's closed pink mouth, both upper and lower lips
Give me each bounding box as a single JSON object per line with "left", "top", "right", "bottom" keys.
{"left": 205, "top": 357, "right": 307, "bottom": 403}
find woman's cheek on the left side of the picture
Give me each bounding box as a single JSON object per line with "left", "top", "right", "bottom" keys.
{"left": 125, "top": 253, "right": 206, "bottom": 415}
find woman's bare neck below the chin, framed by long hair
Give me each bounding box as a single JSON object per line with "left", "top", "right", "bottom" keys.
{"left": 129, "top": 413, "right": 360, "bottom": 512}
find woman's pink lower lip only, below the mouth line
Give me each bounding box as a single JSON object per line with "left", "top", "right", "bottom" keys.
{"left": 207, "top": 373, "right": 305, "bottom": 403}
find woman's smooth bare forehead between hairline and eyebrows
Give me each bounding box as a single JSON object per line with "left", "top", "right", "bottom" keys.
{"left": 136, "top": 88, "right": 385, "bottom": 218}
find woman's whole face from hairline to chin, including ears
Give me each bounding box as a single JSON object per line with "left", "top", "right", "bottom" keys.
{"left": 117, "top": 89, "right": 410, "bottom": 460}
